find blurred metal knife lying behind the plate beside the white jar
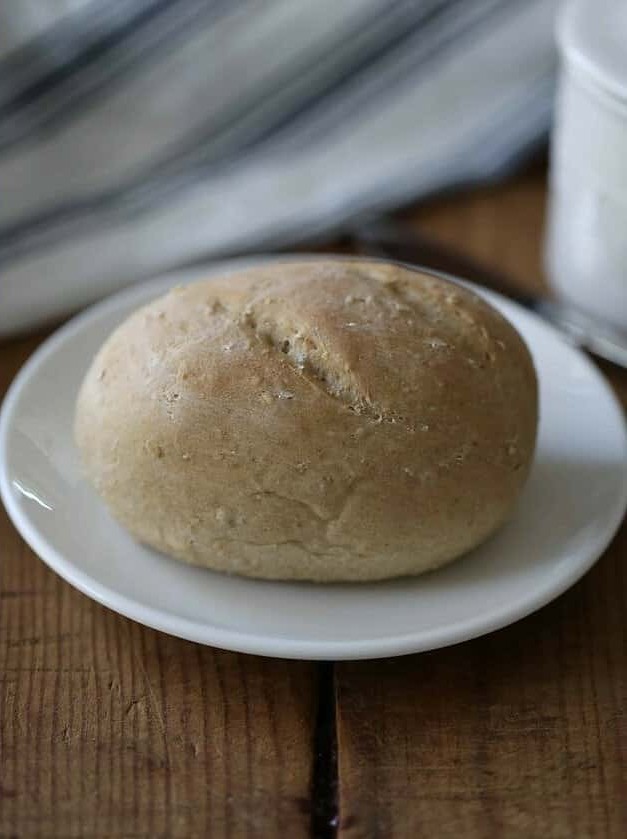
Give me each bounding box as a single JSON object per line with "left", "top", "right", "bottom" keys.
{"left": 348, "top": 220, "right": 627, "bottom": 367}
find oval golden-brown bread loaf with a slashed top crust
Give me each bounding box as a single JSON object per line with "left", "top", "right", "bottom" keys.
{"left": 76, "top": 259, "right": 537, "bottom": 582}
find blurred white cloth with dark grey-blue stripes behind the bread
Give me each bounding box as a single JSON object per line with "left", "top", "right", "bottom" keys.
{"left": 0, "top": 0, "right": 556, "bottom": 335}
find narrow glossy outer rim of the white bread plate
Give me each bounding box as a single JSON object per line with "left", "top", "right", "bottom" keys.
{"left": 0, "top": 254, "right": 627, "bottom": 660}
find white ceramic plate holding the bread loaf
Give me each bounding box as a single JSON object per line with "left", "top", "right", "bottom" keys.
{"left": 0, "top": 260, "right": 627, "bottom": 659}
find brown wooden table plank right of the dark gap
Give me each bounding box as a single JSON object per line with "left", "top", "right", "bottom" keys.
{"left": 336, "top": 164, "right": 627, "bottom": 839}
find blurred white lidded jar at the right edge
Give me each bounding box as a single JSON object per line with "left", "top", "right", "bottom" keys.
{"left": 545, "top": 0, "right": 627, "bottom": 328}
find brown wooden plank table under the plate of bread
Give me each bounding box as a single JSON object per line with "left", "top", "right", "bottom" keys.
{"left": 0, "top": 171, "right": 627, "bottom": 839}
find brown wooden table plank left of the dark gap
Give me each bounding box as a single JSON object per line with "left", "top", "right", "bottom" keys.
{"left": 0, "top": 339, "right": 317, "bottom": 839}
